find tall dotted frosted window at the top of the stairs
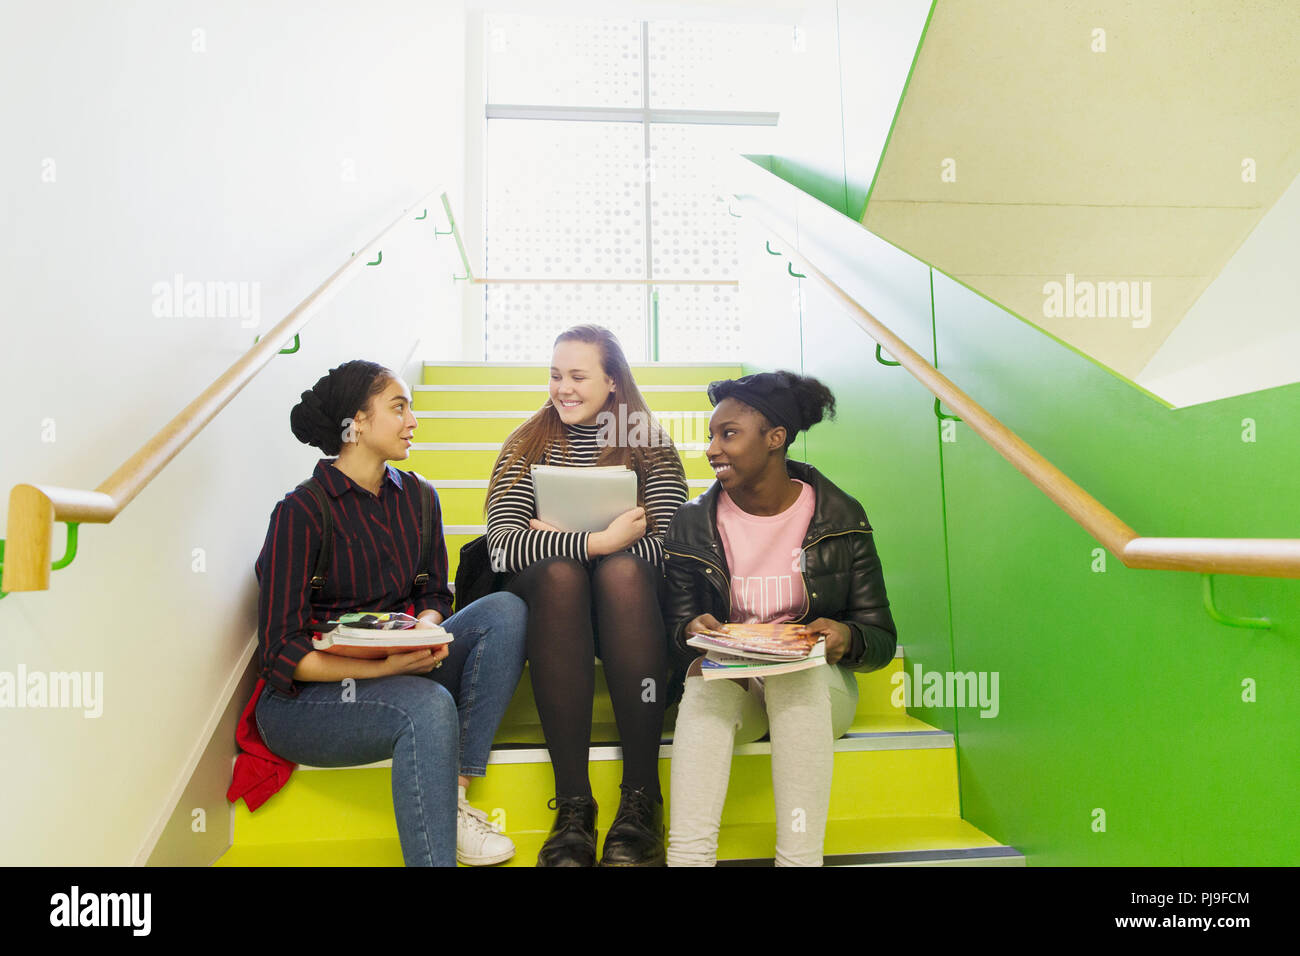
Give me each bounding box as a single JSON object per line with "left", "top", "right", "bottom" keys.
{"left": 484, "top": 16, "right": 798, "bottom": 362}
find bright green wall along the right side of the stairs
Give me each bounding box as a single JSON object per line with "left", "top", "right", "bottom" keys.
{"left": 746, "top": 0, "right": 1300, "bottom": 865}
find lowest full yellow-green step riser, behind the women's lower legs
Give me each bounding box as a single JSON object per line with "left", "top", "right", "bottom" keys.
{"left": 235, "top": 748, "right": 958, "bottom": 845}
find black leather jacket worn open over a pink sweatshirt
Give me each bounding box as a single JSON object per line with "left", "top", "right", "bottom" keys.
{"left": 664, "top": 459, "right": 898, "bottom": 676}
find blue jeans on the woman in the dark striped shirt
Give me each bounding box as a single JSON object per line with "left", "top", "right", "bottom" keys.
{"left": 254, "top": 592, "right": 528, "bottom": 866}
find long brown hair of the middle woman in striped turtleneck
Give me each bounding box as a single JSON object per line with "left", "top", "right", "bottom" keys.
{"left": 484, "top": 325, "right": 685, "bottom": 535}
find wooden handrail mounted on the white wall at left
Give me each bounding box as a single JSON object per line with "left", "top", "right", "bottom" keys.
{"left": 0, "top": 190, "right": 437, "bottom": 592}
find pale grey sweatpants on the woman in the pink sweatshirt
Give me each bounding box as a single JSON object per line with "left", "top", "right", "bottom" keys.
{"left": 668, "top": 665, "right": 857, "bottom": 866}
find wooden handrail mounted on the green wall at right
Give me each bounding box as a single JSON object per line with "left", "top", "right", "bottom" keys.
{"left": 736, "top": 197, "right": 1300, "bottom": 578}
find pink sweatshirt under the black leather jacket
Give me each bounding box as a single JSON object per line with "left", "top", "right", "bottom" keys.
{"left": 718, "top": 479, "right": 816, "bottom": 624}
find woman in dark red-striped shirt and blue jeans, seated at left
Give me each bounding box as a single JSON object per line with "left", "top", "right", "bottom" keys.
{"left": 228, "top": 360, "right": 527, "bottom": 866}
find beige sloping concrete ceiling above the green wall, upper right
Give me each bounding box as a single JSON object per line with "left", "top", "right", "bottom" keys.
{"left": 862, "top": 0, "right": 1300, "bottom": 405}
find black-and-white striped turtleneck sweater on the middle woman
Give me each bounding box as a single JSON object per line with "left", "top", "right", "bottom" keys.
{"left": 488, "top": 425, "right": 688, "bottom": 571}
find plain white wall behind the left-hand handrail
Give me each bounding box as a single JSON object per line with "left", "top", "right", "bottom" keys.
{"left": 0, "top": 0, "right": 465, "bottom": 865}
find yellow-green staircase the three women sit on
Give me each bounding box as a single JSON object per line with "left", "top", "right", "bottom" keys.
{"left": 216, "top": 363, "right": 1024, "bottom": 866}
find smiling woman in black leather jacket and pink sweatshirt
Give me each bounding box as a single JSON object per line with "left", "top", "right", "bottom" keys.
{"left": 664, "top": 372, "right": 897, "bottom": 866}
